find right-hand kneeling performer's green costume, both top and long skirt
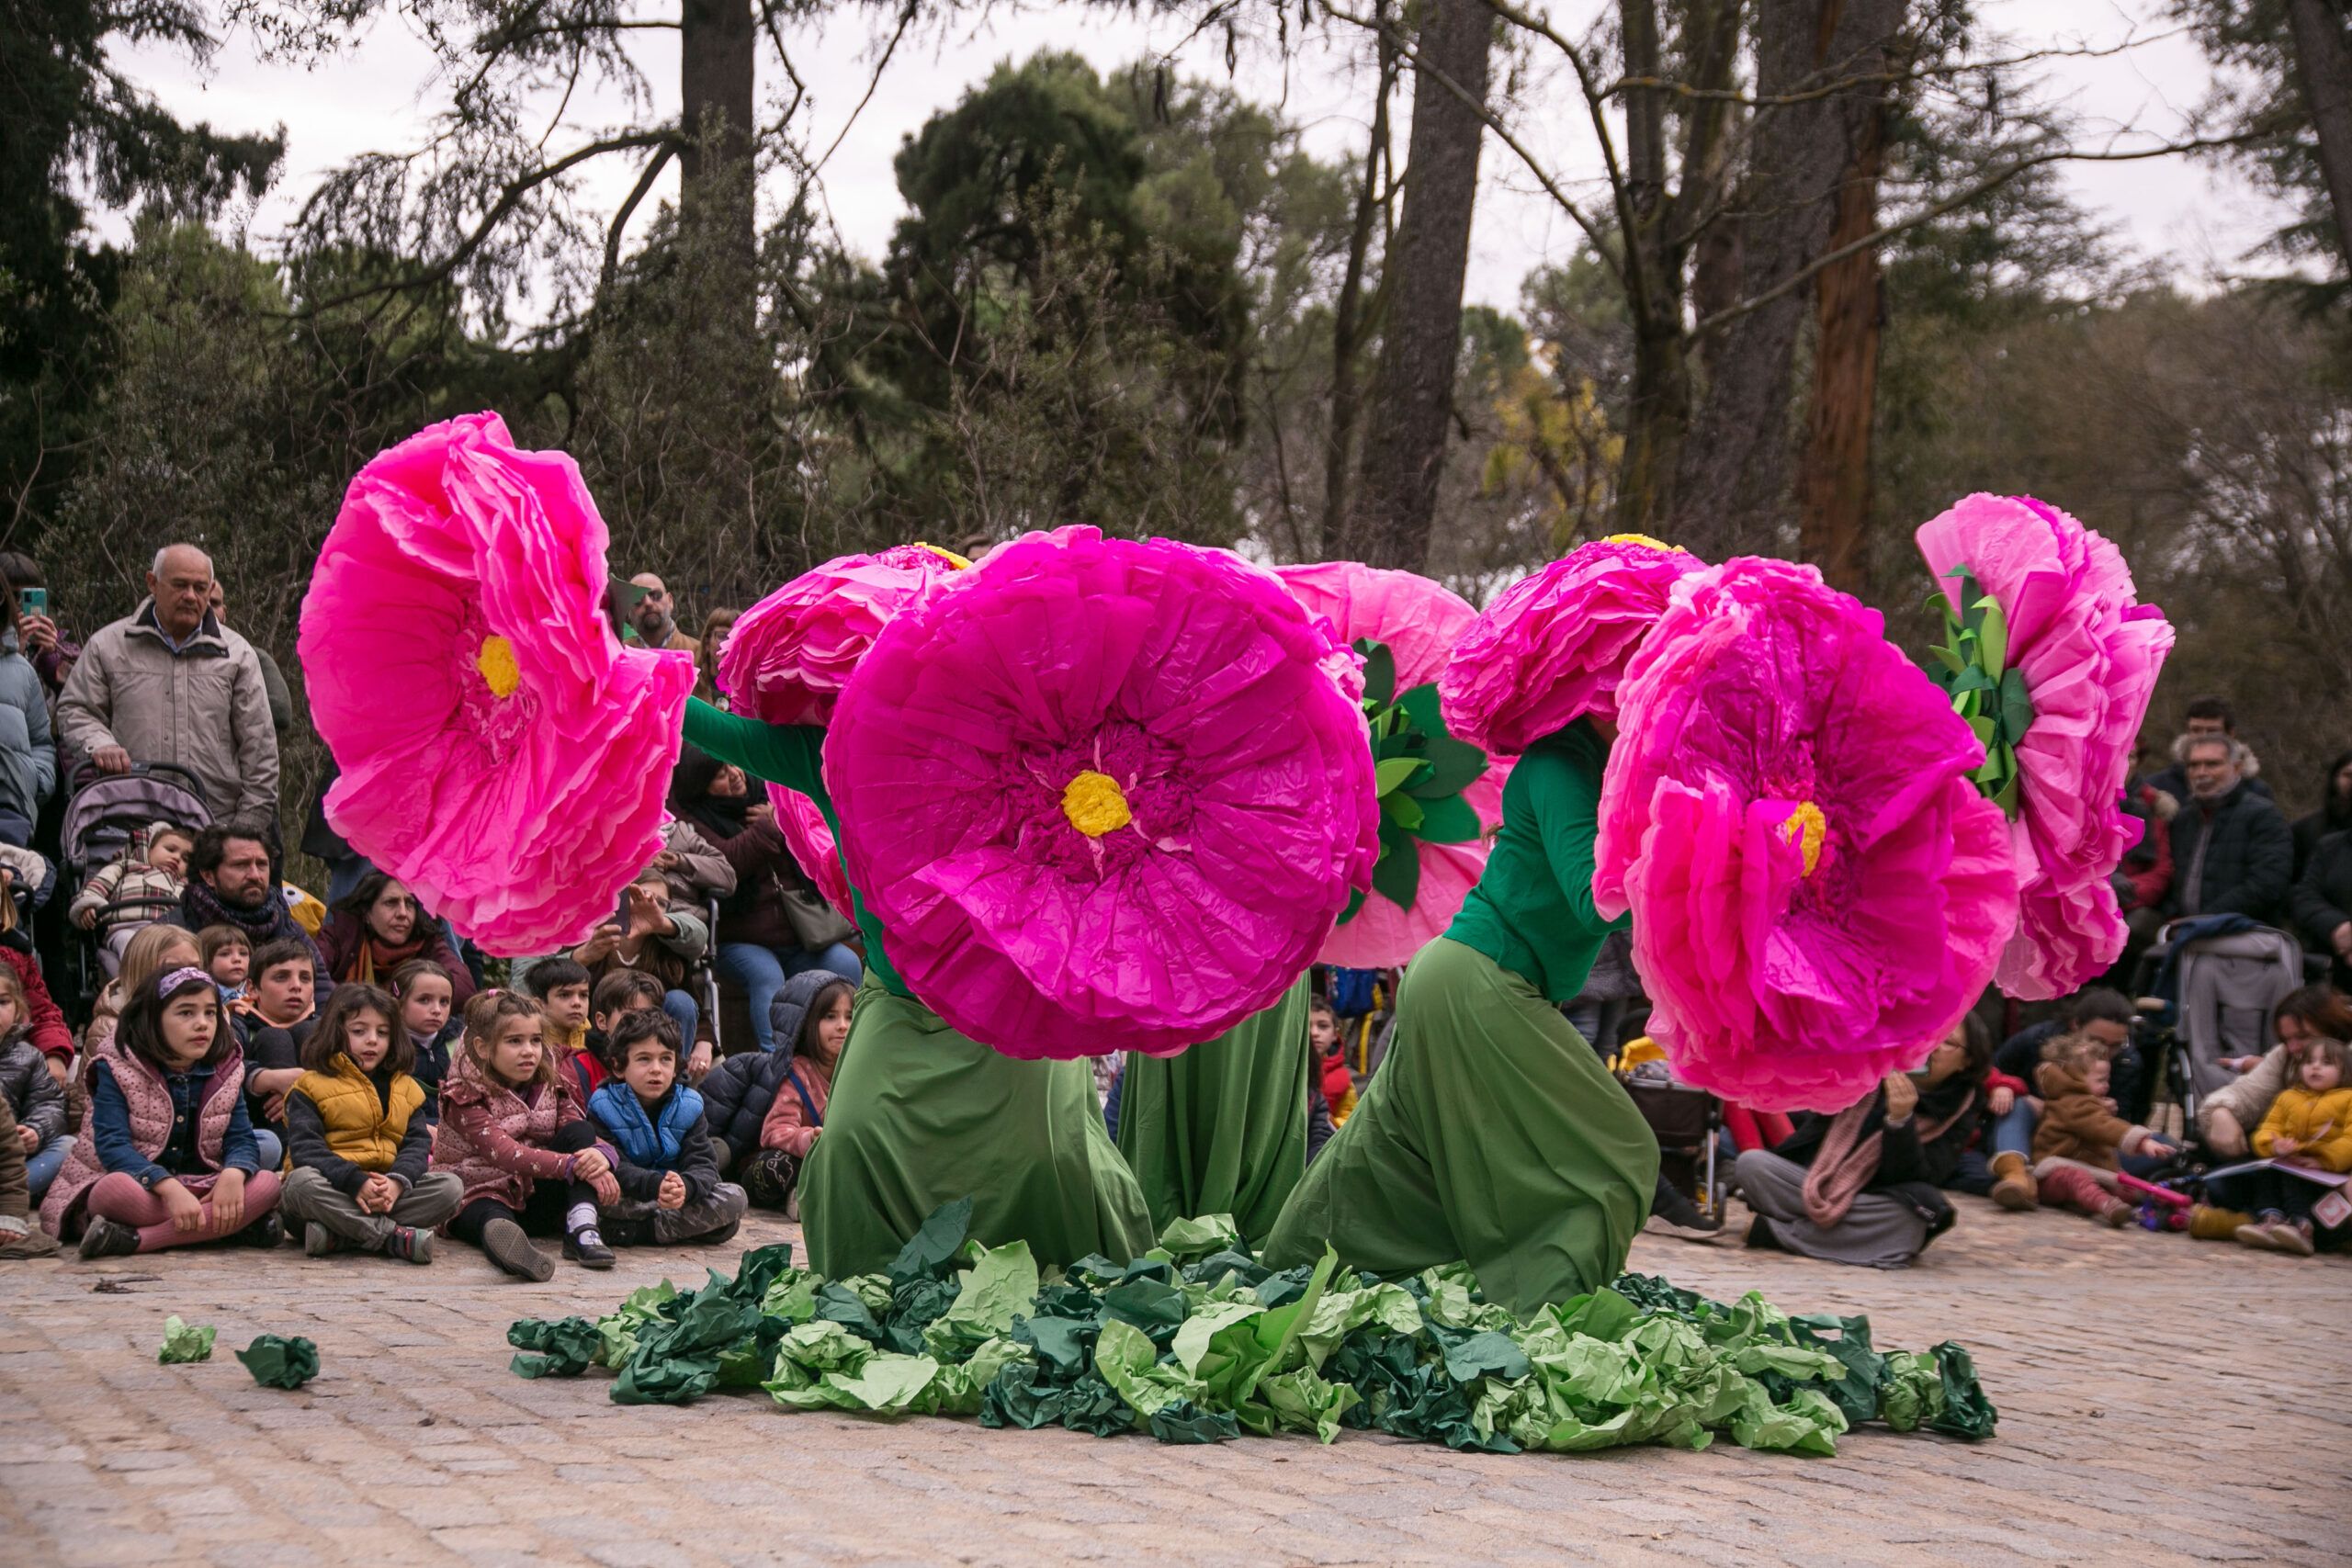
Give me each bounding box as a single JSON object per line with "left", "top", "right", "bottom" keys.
{"left": 1265, "top": 719, "right": 1658, "bottom": 1319}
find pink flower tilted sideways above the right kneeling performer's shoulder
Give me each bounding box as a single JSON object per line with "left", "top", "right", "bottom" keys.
{"left": 1437, "top": 534, "right": 1708, "bottom": 757}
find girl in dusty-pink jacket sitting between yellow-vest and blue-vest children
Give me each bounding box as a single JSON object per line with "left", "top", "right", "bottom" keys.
{"left": 435, "top": 992, "right": 621, "bottom": 1281}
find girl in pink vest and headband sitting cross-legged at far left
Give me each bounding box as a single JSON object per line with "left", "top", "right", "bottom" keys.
{"left": 40, "top": 964, "right": 285, "bottom": 1260}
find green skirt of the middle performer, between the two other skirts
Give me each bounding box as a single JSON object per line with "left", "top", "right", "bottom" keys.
{"left": 1120, "top": 976, "right": 1310, "bottom": 1248}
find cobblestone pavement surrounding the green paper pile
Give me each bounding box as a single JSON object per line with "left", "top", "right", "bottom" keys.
{"left": 0, "top": 1199, "right": 2352, "bottom": 1568}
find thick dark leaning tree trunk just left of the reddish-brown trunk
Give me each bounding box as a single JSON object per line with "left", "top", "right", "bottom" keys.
{"left": 1672, "top": 0, "right": 1907, "bottom": 559}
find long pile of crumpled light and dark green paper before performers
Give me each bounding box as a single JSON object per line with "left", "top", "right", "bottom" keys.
{"left": 505, "top": 1201, "right": 1999, "bottom": 1455}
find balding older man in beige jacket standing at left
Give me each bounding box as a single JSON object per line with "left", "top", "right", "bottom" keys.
{"left": 56, "top": 543, "right": 277, "bottom": 820}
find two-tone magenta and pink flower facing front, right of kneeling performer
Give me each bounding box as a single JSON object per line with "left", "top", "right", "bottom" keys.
{"left": 1592, "top": 558, "right": 2018, "bottom": 1110}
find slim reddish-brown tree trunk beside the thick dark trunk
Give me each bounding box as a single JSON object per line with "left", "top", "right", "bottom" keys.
{"left": 1797, "top": 101, "right": 1886, "bottom": 594}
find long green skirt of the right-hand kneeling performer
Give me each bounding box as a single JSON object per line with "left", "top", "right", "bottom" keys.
{"left": 1265, "top": 938, "right": 1658, "bottom": 1316}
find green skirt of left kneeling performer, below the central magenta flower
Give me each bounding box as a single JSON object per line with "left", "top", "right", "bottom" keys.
{"left": 799, "top": 971, "right": 1158, "bottom": 1279}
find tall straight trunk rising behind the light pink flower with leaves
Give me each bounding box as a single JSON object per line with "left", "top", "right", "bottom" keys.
{"left": 1352, "top": 0, "right": 1494, "bottom": 571}
